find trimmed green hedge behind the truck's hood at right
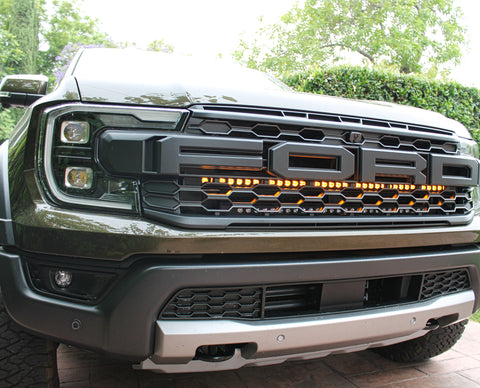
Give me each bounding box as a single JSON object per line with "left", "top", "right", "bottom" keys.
{"left": 284, "top": 66, "right": 480, "bottom": 141}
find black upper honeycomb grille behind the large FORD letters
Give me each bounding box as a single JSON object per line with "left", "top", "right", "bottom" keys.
{"left": 137, "top": 106, "right": 473, "bottom": 228}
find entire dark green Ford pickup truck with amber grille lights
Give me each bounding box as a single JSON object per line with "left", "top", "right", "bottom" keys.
{"left": 0, "top": 49, "right": 480, "bottom": 387}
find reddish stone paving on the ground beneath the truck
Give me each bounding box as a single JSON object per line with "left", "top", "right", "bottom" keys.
{"left": 58, "top": 322, "right": 480, "bottom": 388}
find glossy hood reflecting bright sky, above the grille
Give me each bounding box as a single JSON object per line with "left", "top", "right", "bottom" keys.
{"left": 71, "top": 49, "right": 469, "bottom": 137}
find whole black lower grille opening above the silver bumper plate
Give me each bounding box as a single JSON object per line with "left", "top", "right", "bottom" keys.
{"left": 160, "top": 269, "right": 470, "bottom": 319}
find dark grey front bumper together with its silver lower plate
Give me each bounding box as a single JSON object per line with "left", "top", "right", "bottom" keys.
{"left": 0, "top": 245, "right": 480, "bottom": 362}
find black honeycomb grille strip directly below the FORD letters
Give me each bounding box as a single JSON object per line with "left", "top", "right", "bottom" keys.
{"left": 143, "top": 178, "right": 473, "bottom": 217}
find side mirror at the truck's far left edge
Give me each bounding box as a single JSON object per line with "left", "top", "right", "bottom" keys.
{"left": 0, "top": 74, "right": 48, "bottom": 108}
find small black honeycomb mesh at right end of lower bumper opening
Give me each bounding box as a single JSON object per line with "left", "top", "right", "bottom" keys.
{"left": 420, "top": 271, "right": 470, "bottom": 299}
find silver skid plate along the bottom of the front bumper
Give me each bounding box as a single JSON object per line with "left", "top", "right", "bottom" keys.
{"left": 137, "top": 291, "right": 475, "bottom": 373}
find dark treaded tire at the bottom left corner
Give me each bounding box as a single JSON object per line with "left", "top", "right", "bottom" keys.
{"left": 0, "top": 293, "right": 59, "bottom": 388}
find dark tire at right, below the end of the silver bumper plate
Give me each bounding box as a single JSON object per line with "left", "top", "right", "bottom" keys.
{"left": 373, "top": 320, "right": 468, "bottom": 362}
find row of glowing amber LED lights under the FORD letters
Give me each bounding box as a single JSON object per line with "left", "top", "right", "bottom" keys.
{"left": 202, "top": 177, "right": 446, "bottom": 193}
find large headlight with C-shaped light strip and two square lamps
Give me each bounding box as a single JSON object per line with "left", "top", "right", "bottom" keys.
{"left": 38, "top": 104, "right": 188, "bottom": 211}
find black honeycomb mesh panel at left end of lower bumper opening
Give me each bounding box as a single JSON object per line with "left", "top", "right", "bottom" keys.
{"left": 162, "top": 288, "right": 262, "bottom": 319}
